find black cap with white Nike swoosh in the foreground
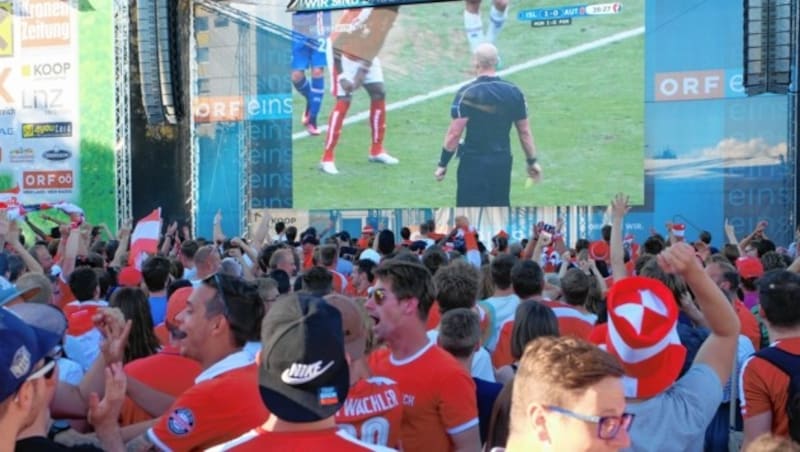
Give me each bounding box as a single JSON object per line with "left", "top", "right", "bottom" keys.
{"left": 258, "top": 293, "right": 350, "bottom": 422}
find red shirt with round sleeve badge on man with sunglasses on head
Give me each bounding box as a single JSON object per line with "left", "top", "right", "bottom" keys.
{"left": 147, "top": 351, "right": 269, "bottom": 451}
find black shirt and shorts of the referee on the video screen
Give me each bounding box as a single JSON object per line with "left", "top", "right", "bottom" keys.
{"left": 450, "top": 76, "right": 528, "bottom": 207}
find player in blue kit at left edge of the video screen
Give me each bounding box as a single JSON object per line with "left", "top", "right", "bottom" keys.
{"left": 292, "top": 11, "right": 331, "bottom": 135}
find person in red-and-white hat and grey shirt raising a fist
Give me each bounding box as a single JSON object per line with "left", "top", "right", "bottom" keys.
{"left": 604, "top": 244, "right": 739, "bottom": 452}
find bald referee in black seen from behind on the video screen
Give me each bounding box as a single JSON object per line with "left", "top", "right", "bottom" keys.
{"left": 434, "top": 43, "right": 542, "bottom": 206}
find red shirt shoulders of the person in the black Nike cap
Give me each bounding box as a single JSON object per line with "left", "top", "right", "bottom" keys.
{"left": 207, "top": 427, "right": 392, "bottom": 452}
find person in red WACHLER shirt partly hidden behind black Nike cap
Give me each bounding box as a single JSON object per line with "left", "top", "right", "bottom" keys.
{"left": 325, "top": 294, "right": 403, "bottom": 448}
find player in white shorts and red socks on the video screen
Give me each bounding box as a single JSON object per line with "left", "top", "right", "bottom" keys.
{"left": 319, "top": 6, "right": 400, "bottom": 174}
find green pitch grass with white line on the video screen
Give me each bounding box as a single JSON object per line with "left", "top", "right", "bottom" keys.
{"left": 293, "top": 0, "right": 645, "bottom": 209}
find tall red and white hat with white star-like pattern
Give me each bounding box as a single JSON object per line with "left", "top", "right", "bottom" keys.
{"left": 605, "top": 276, "right": 686, "bottom": 398}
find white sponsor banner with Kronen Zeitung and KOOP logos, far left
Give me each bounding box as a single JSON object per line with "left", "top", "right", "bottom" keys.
{"left": 0, "top": 0, "right": 80, "bottom": 203}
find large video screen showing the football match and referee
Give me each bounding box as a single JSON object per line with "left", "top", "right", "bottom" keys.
{"left": 292, "top": 0, "right": 645, "bottom": 209}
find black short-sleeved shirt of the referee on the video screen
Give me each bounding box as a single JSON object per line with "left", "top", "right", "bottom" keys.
{"left": 450, "top": 76, "right": 528, "bottom": 154}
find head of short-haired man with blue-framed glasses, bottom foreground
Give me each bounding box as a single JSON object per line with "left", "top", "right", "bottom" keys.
{"left": 505, "top": 337, "right": 632, "bottom": 452}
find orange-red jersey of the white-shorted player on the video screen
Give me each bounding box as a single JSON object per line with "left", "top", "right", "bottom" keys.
{"left": 331, "top": 6, "right": 400, "bottom": 62}
